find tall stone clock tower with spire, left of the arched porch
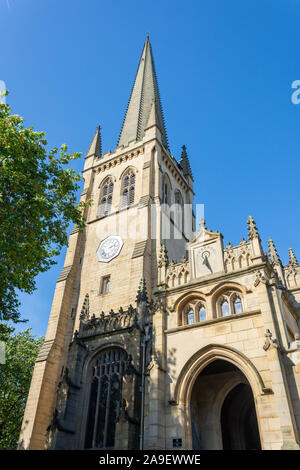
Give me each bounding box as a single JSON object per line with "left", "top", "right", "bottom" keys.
{"left": 20, "top": 37, "right": 194, "bottom": 449}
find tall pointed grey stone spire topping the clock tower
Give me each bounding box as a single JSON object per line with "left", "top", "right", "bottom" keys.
{"left": 118, "top": 36, "right": 168, "bottom": 148}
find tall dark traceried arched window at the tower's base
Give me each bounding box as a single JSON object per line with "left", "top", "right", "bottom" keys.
{"left": 84, "top": 348, "right": 127, "bottom": 449}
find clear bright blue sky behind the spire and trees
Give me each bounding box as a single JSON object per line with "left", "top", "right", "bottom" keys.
{"left": 0, "top": 0, "right": 300, "bottom": 335}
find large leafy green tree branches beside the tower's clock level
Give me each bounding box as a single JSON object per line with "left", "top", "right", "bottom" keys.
{"left": 0, "top": 93, "right": 90, "bottom": 322}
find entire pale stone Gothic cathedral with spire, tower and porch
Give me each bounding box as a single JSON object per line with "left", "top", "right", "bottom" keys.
{"left": 19, "top": 38, "right": 300, "bottom": 450}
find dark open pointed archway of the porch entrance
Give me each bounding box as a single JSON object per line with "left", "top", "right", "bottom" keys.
{"left": 190, "top": 359, "right": 261, "bottom": 450}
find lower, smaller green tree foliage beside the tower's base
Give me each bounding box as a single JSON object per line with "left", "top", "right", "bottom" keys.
{"left": 0, "top": 328, "right": 44, "bottom": 450}
